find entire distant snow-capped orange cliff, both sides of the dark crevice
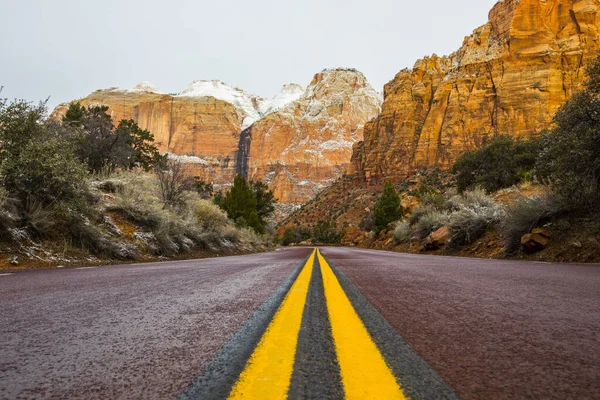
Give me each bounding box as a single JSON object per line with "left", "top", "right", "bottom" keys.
{"left": 53, "top": 69, "right": 381, "bottom": 204}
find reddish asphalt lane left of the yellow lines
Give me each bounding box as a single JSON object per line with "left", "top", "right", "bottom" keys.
{"left": 0, "top": 249, "right": 311, "bottom": 399}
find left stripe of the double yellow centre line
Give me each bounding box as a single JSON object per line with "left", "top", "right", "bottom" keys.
{"left": 229, "top": 250, "right": 316, "bottom": 400}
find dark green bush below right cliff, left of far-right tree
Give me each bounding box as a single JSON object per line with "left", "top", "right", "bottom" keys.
{"left": 452, "top": 135, "right": 540, "bottom": 193}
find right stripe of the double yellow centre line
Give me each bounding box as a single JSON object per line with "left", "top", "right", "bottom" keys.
{"left": 317, "top": 251, "right": 406, "bottom": 400}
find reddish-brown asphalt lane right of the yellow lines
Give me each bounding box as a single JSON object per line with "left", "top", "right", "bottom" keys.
{"left": 323, "top": 248, "right": 600, "bottom": 400}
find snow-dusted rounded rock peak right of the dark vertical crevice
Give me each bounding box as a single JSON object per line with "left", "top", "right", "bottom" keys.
{"left": 240, "top": 68, "right": 381, "bottom": 204}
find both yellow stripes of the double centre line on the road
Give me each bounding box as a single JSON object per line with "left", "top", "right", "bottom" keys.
{"left": 229, "top": 249, "right": 405, "bottom": 399}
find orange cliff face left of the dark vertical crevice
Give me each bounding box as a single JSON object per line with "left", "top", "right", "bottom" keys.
{"left": 53, "top": 89, "right": 244, "bottom": 184}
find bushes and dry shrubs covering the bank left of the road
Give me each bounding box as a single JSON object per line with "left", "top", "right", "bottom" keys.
{"left": 0, "top": 99, "right": 275, "bottom": 264}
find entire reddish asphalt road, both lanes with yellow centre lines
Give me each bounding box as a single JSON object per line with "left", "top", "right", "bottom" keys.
{"left": 0, "top": 247, "right": 600, "bottom": 399}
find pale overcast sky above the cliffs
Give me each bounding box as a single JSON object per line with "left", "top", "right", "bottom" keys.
{"left": 0, "top": 0, "right": 496, "bottom": 107}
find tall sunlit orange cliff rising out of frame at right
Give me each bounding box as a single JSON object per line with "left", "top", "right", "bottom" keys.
{"left": 348, "top": 0, "right": 600, "bottom": 181}
